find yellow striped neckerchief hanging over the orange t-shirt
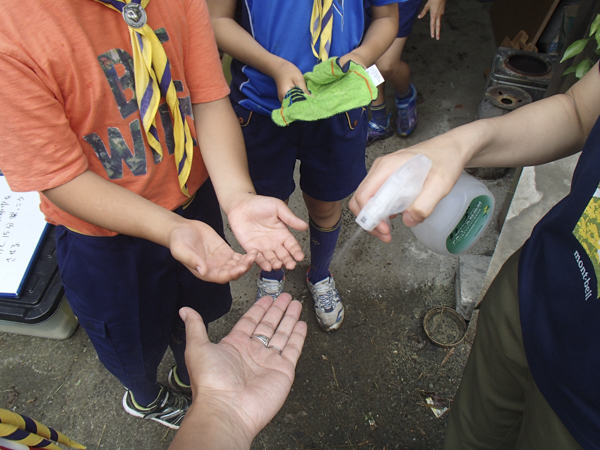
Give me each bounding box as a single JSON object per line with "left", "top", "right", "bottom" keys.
{"left": 95, "top": 0, "right": 193, "bottom": 195}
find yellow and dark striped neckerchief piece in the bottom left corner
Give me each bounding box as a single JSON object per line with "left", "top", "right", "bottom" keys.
{"left": 0, "top": 408, "right": 85, "bottom": 450}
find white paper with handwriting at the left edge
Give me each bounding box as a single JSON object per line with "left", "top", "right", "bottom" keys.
{"left": 0, "top": 175, "right": 48, "bottom": 297}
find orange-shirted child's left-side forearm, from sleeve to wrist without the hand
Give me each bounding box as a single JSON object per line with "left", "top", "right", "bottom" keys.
{"left": 43, "top": 170, "right": 184, "bottom": 247}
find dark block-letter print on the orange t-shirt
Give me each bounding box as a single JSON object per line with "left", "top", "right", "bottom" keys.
{"left": 83, "top": 28, "right": 196, "bottom": 180}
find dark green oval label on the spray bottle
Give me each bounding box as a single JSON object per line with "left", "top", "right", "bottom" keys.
{"left": 446, "top": 195, "right": 492, "bottom": 255}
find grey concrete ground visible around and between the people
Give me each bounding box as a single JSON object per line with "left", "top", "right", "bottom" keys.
{"left": 0, "top": 0, "right": 502, "bottom": 450}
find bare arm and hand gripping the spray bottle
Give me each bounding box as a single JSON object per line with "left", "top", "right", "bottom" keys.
{"left": 350, "top": 63, "right": 600, "bottom": 242}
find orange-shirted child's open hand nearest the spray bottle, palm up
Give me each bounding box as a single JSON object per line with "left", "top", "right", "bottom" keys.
{"left": 227, "top": 194, "right": 308, "bottom": 271}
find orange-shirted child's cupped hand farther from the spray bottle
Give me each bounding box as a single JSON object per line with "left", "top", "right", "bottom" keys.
{"left": 169, "top": 219, "right": 257, "bottom": 283}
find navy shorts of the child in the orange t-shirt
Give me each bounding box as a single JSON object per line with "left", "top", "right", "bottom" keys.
{"left": 56, "top": 181, "right": 231, "bottom": 390}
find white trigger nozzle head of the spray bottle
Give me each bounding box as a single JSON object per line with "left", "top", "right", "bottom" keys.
{"left": 356, "top": 155, "right": 432, "bottom": 231}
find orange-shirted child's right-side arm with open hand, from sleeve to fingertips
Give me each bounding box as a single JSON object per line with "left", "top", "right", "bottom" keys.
{"left": 192, "top": 97, "right": 308, "bottom": 270}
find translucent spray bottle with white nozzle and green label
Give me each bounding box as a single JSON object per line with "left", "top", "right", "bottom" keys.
{"left": 356, "top": 155, "right": 495, "bottom": 256}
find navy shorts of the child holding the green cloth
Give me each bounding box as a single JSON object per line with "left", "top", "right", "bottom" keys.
{"left": 234, "top": 105, "right": 367, "bottom": 202}
